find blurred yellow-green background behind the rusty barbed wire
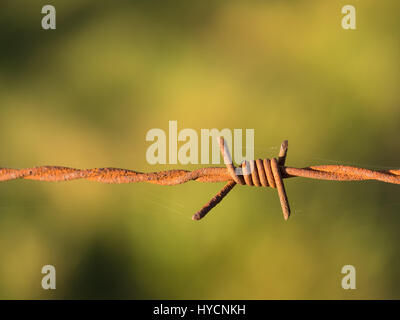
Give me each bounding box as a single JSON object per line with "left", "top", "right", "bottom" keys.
{"left": 0, "top": 0, "right": 400, "bottom": 299}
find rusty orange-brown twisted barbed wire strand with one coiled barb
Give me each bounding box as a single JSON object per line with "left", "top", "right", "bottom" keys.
{"left": 0, "top": 138, "right": 400, "bottom": 220}
